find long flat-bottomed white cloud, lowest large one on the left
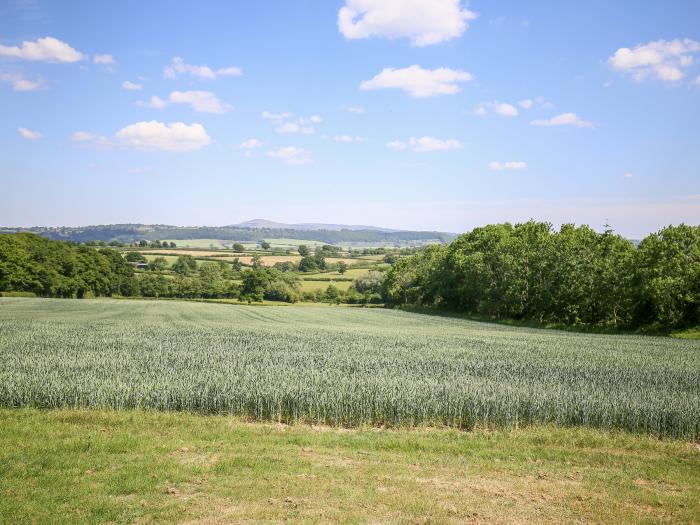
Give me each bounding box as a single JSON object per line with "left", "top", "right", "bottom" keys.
{"left": 116, "top": 120, "right": 211, "bottom": 151}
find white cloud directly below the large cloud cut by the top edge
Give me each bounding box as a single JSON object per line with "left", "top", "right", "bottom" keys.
{"left": 360, "top": 65, "right": 473, "bottom": 98}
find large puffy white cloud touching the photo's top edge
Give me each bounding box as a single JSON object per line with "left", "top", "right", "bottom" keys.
{"left": 338, "top": 0, "right": 477, "bottom": 47}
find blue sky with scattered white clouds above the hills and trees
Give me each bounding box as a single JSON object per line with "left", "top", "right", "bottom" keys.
{"left": 0, "top": 0, "right": 700, "bottom": 233}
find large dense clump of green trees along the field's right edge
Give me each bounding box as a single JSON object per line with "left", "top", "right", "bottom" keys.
{"left": 384, "top": 221, "right": 700, "bottom": 328}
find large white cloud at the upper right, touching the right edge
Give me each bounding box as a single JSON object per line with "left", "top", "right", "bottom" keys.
{"left": 608, "top": 38, "right": 700, "bottom": 82}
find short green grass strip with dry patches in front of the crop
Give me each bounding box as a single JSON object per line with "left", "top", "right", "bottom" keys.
{"left": 0, "top": 409, "right": 700, "bottom": 524}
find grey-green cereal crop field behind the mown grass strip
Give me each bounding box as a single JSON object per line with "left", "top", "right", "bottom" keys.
{"left": 0, "top": 298, "right": 700, "bottom": 440}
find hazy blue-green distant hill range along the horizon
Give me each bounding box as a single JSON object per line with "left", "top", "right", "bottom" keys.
{"left": 0, "top": 219, "right": 456, "bottom": 245}
